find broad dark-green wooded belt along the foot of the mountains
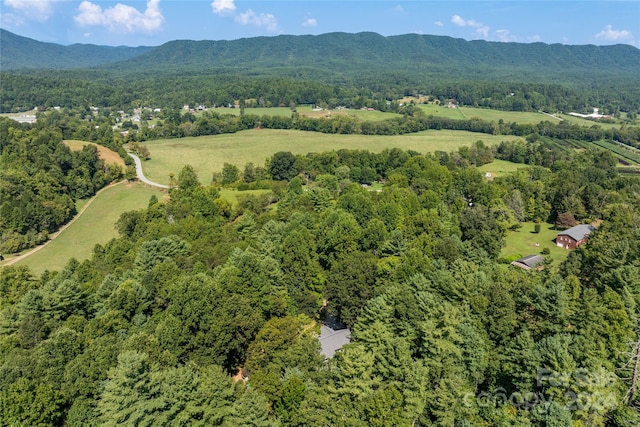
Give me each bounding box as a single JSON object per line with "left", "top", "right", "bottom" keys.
{"left": 0, "top": 70, "right": 640, "bottom": 115}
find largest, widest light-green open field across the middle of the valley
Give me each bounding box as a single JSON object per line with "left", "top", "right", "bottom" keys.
{"left": 142, "top": 129, "right": 519, "bottom": 184}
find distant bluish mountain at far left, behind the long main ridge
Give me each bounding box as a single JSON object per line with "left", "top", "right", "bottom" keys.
{"left": 0, "top": 28, "right": 153, "bottom": 71}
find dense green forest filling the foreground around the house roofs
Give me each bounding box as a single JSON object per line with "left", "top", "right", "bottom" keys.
{"left": 0, "top": 130, "right": 640, "bottom": 426}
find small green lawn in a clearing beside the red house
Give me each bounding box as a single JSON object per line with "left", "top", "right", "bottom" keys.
{"left": 500, "top": 222, "right": 569, "bottom": 266}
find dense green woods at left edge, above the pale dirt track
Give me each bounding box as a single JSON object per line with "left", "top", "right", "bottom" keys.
{"left": 0, "top": 117, "right": 123, "bottom": 253}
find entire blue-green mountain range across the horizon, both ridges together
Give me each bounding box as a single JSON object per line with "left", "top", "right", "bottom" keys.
{"left": 0, "top": 30, "right": 640, "bottom": 83}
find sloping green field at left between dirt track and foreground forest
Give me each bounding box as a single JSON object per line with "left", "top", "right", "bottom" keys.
{"left": 15, "top": 183, "right": 165, "bottom": 275}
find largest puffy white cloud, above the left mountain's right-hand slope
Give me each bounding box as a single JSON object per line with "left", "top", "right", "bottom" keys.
{"left": 74, "top": 0, "right": 164, "bottom": 33}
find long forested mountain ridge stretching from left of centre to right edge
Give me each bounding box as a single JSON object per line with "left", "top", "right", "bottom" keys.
{"left": 118, "top": 33, "right": 640, "bottom": 77}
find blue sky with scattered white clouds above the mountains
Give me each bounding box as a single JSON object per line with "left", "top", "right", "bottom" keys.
{"left": 0, "top": 0, "right": 640, "bottom": 47}
